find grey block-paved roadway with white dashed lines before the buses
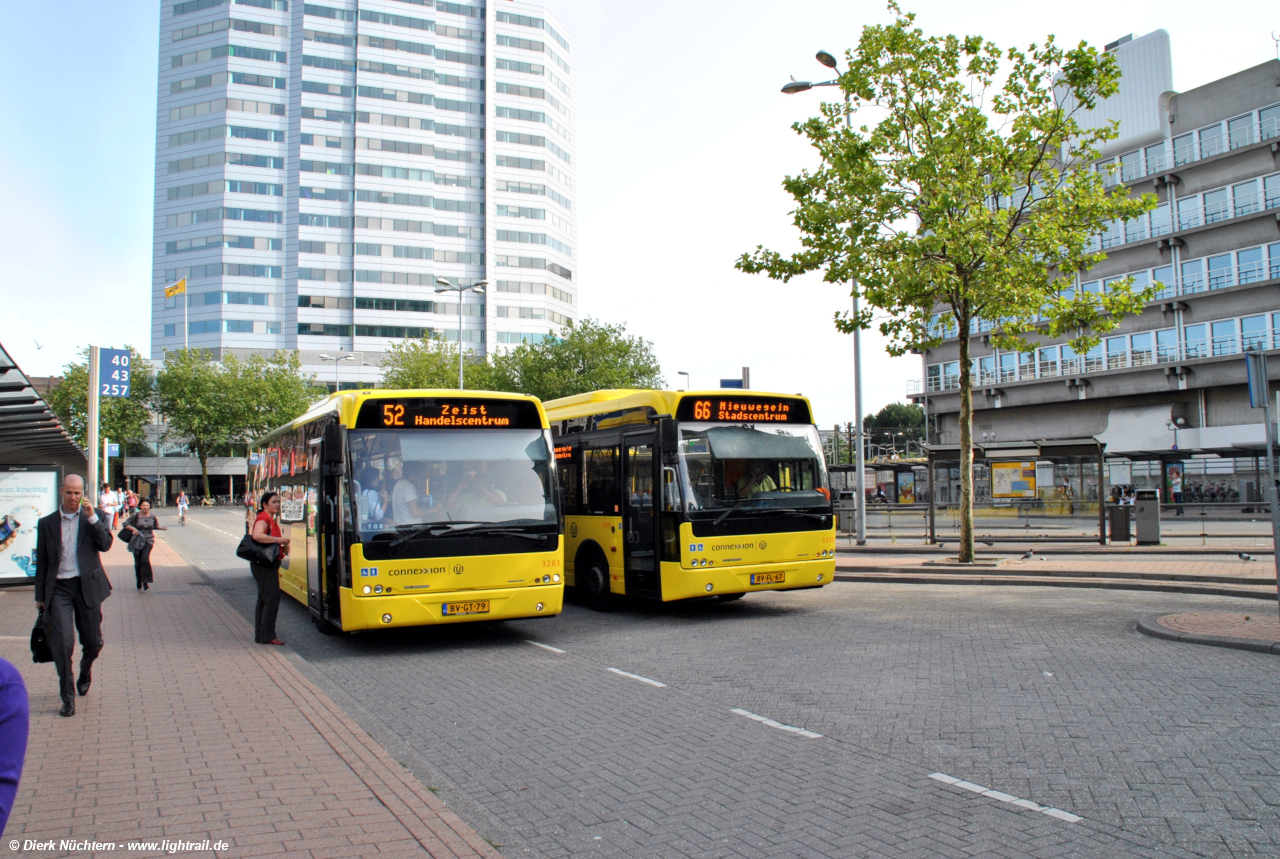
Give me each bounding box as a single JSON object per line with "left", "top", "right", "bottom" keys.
{"left": 156, "top": 510, "right": 1280, "bottom": 858}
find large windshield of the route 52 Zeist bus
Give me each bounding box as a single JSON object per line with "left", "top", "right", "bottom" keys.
{"left": 348, "top": 429, "right": 557, "bottom": 539}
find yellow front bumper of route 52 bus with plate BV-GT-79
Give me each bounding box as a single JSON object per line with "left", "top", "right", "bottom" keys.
{"left": 340, "top": 584, "right": 564, "bottom": 632}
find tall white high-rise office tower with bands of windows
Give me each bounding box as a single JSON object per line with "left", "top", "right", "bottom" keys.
{"left": 151, "top": 0, "right": 579, "bottom": 387}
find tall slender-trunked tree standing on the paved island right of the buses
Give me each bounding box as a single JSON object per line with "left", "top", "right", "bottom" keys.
{"left": 737, "top": 4, "right": 1158, "bottom": 562}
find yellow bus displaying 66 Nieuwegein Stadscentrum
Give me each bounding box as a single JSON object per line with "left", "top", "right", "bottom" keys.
{"left": 545, "top": 390, "right": 836, "bottom": 611}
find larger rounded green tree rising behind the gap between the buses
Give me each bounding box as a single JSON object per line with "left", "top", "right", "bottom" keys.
{"left": 493, "top": 317, "right": 663, "bottom": 402}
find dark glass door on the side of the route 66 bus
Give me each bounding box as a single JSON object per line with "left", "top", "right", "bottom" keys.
{"left": 622, "top": 433, "right": 662, "bottom": 597}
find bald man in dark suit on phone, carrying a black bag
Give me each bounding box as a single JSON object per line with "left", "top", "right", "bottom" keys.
{"left": 36, "top": 474, "right": 111, "bottom": 716}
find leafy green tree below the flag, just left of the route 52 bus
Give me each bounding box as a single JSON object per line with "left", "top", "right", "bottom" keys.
{"left": 156, "top": 349, "right": 325, "bottom": 495}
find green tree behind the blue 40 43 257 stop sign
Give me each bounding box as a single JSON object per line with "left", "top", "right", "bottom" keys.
{"left": 45, "top": 346, "right": 156, "bottom": 485}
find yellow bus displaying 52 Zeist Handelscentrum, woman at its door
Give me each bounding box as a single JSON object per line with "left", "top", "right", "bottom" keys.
{"left": 250, "top": 390, "right": 564, "bottom": 632}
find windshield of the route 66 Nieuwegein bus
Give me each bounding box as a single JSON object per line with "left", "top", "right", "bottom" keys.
{"left": 680, "top": 424, "right": 831, "bottom": 512}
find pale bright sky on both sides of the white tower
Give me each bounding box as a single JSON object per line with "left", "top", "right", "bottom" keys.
{"left": 0, "top": 0, "right": 1280, "bottom": 425}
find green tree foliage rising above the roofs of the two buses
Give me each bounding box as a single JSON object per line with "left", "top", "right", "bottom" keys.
{"left": 383, "top": 317, "right": 663, "bottom": 401}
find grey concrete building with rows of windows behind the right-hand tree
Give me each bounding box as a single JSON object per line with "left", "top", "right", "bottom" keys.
{"left": 909, "top": 31, "right": 1280, "bottom": 501}
